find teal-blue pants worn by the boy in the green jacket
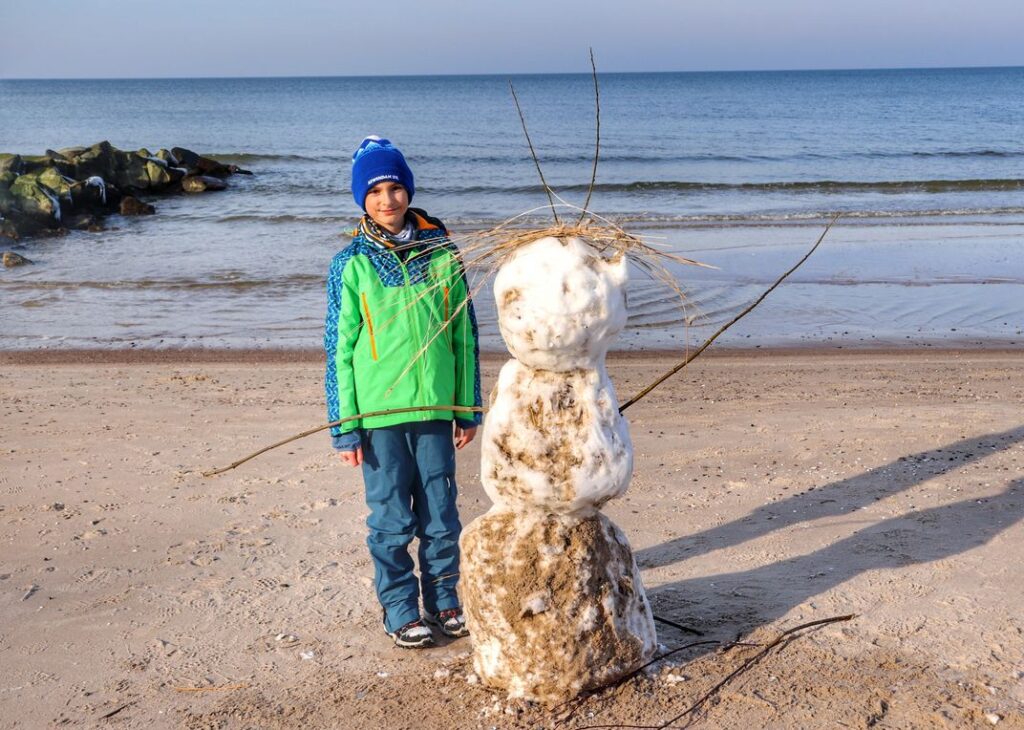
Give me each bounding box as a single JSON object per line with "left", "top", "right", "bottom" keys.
{"left": 362, "top": 421, "right": 462, "bottom": 632}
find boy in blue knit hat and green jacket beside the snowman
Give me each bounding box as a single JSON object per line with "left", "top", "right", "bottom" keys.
{"left": 324, "top": 136, "right": 480, "bottom": 648}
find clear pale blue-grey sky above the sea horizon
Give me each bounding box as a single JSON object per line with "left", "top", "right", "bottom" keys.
{"left": 0, "top": 0, "right": 1024, "bottom": 79}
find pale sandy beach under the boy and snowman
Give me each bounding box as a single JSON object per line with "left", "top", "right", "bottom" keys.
{"left": 0, "top": 350, "right": 1024, "bottom": 730}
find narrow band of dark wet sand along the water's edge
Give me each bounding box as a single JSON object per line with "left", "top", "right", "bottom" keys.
{"left": 0, "top": 341, "right": 1024, "bottom": 366}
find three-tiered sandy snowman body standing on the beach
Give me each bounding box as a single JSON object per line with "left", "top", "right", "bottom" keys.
{"left": 461, "top": 237, "right": 656, "bottom": 703}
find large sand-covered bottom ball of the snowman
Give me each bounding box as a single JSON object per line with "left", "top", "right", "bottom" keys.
{"left": 460, "top": 511, "right": 656, "bottom": 704}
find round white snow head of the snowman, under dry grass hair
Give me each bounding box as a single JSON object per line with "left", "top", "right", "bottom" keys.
{"left": 495, "top": 237, "right": 628, "bottom": 371}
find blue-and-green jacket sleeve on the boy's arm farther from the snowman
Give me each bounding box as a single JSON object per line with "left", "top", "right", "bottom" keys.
{"left": 324, "top": 246, "right": 361, "bottom": 436}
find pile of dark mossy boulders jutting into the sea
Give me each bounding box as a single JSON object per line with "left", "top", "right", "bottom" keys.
{"left": 0, "top": 141, "right": 252, "bottom": 240}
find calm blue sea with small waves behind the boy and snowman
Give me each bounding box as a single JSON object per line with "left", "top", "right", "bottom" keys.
{"left": 0, "top": 68, "right": 1024, "bottom": 351}
